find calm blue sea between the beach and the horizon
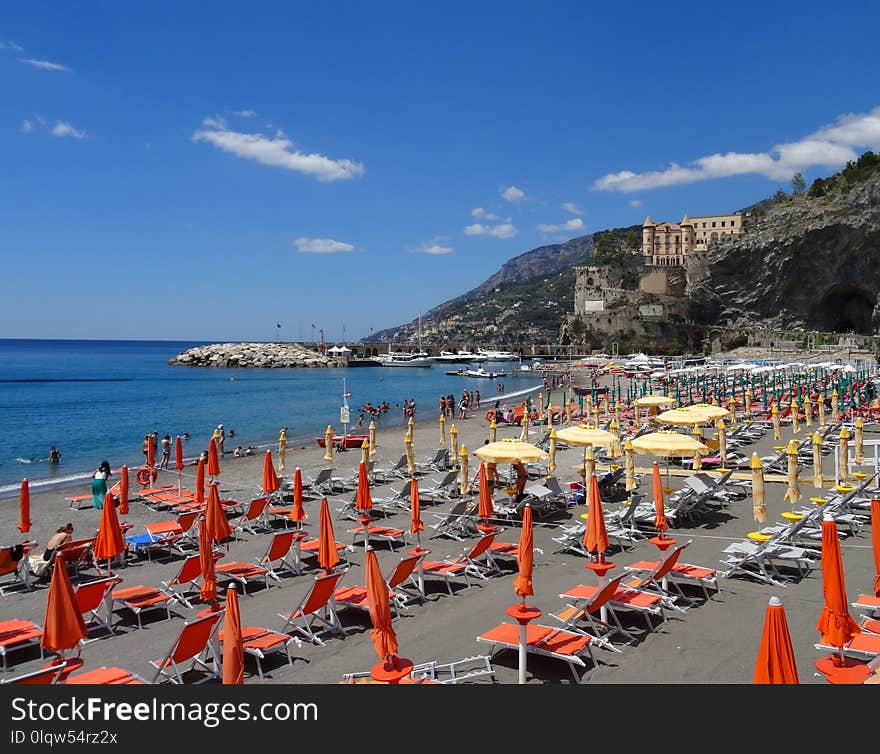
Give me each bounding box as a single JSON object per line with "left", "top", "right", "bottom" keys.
{"left": 0, "top": 339, "right": 543, "bottom": 498}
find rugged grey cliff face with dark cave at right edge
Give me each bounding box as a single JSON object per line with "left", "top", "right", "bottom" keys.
{"left": 687, "top": 174, "right": 880, "bottom": 334}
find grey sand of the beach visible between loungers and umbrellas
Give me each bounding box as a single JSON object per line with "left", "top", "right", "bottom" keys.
{"left": 0, "top": 376, "right": 880, "bottom": 684}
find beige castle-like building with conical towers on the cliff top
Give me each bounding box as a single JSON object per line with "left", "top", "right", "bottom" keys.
{"left": 642, "top": 212, "right": 745, "bottom": 267}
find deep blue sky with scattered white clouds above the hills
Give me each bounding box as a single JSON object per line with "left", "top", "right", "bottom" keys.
{"left": 0, "top": 2, "right": 880, "bottom": 340}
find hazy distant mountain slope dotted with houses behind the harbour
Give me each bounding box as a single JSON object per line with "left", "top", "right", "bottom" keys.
{"left": 364, "top": 235, "right": 594, "bottom": 347}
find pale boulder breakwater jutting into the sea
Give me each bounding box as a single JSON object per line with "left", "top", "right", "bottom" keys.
{"left": 168, "top": 343, "right": 344, "bottom": 369}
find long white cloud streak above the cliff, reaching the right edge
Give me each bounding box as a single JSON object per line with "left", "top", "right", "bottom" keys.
{"left": 593, "top": 107, "right": 880, "bottom": 192}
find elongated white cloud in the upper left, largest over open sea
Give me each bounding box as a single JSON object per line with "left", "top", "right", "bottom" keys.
{"left": 192, "top": 118, "right": 364, "bottom": 182}
